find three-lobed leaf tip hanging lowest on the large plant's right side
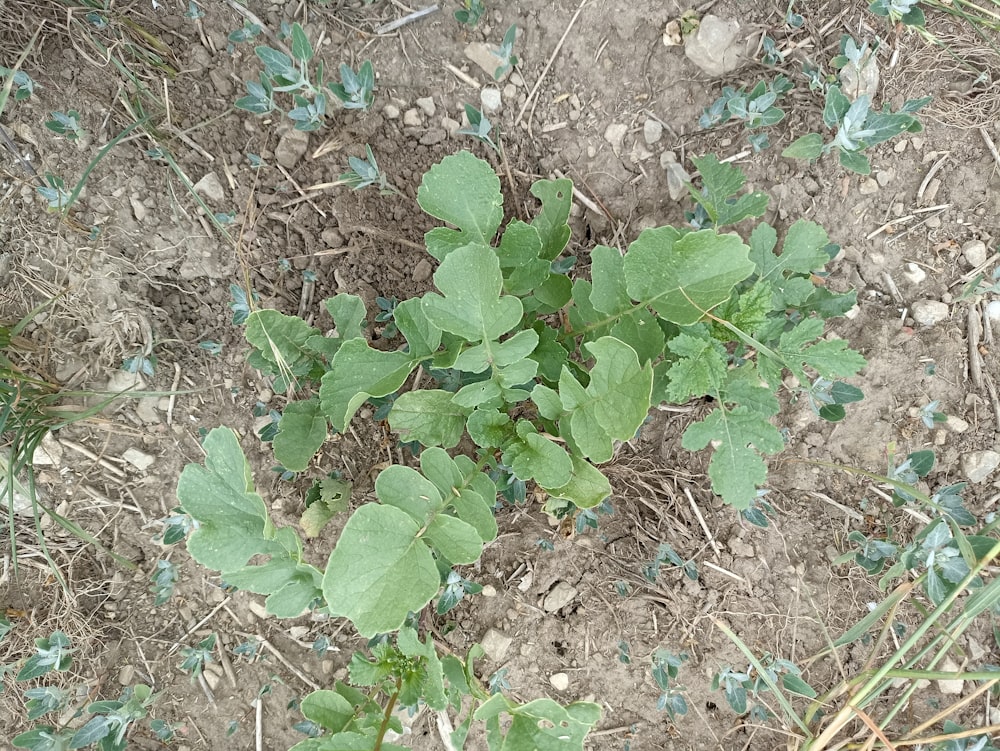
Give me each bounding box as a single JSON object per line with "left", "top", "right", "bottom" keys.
{"left": 681, "top": 407, "right": 785, "bottom": 511}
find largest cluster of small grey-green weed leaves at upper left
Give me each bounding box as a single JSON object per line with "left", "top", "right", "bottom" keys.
{"left": 236, "top": 23, "right": 375, "bottom": 131}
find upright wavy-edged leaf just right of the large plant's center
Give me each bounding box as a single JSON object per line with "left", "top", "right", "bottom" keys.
{"left": 560, "top": 337, "right": 653, "bottom": 463}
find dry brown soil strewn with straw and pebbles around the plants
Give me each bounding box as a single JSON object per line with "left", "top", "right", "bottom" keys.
{"left": 0, "top": 0, "right": 1000, "bottom": 751}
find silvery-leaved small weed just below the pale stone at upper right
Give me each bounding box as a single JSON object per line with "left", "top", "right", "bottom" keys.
{"left": 781, "top": 86, "right": 931, "bottom": 175}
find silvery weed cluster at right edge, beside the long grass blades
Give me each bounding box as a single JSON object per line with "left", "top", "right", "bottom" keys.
{"left": 836, "top": 451, "right": 996, "bottom": 605}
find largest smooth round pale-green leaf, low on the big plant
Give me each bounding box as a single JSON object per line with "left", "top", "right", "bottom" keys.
{"left": 323, "top": 503, "right": 440, "bottom": 638}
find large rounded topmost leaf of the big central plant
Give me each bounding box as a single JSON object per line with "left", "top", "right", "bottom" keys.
{"left": 417, "top": 151, "right": 503, "bottom": 261}
